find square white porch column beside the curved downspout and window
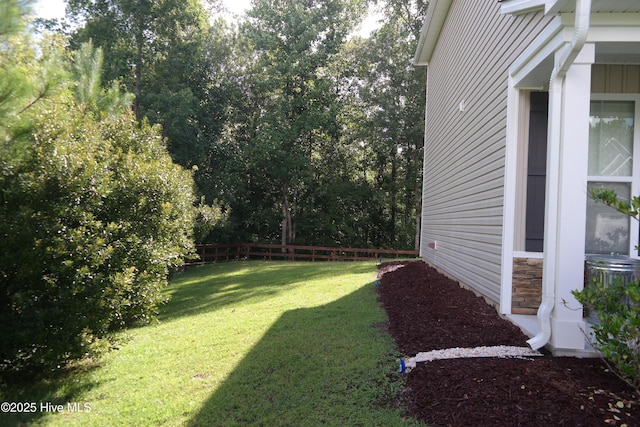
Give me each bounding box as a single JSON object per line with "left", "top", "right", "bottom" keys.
{"left": 543, "top": 44, "right": 595, "bottom": 350}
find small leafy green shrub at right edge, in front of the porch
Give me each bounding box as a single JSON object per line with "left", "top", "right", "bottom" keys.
{"left": 572, "top": 279, "right": 640, "bottom": 391}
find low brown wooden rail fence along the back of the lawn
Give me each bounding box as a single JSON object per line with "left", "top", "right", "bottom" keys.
{"left": 191, "top": 243, "right": 418, "bottom": 264}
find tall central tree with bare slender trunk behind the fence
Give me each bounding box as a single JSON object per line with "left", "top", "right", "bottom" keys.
{"left": 243, "top": 0, "right": 366, "bottom": 244}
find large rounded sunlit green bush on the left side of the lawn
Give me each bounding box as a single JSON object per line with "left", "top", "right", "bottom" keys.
{"left": 0, "top": 107, "right": 194, "bottom": 378}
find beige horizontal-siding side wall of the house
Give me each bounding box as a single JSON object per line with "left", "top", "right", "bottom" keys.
{"left": 420, "top": 0, "right": 549, "bottom": 302}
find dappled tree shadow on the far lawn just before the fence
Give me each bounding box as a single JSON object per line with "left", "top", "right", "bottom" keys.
{"left": 158, "top": 261, "right": 378, "bottom": 321}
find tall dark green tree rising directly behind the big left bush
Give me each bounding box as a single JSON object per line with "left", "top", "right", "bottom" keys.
{"left": 68, "top": 0, "right": 222, "bottom": 167}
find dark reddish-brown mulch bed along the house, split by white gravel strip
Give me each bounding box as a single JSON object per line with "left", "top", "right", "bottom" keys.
{"left": 378, "top": 261, "right": 640, "bottom": 427}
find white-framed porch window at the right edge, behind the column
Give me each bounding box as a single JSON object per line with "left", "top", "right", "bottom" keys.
{"left": 585, "top": 95, "right": 640, "bottom": 257}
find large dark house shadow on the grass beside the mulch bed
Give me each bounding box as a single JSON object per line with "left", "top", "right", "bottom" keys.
{"left": 182, "top": 280, "right": 407, "bottom": 427}
